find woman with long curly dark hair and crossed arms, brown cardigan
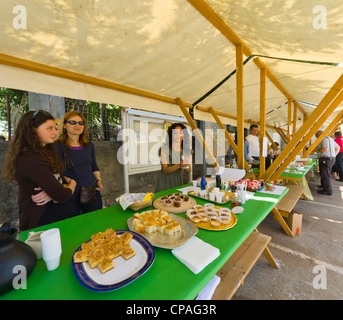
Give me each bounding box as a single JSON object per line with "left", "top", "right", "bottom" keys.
{"left": 2, "top": 110, "right": 76, "bottom": 230}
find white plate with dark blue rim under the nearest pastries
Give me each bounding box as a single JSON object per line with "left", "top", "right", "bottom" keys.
{"left": 71, "top": 230, "right": 155, "bottom": 292}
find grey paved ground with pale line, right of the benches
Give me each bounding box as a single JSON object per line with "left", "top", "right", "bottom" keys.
{"left": 233, "top": 174, "right": 343, "bottom": 300}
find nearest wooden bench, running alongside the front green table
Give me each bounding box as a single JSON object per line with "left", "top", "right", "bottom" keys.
{"left": 212, "top": 230, "right": 278, "bottom": 300}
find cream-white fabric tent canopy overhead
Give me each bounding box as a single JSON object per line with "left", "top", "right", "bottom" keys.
{"left": 0, "top": 0, "right": 343, "bottom": 129}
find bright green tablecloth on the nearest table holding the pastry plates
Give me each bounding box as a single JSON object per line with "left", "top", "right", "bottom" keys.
{"left": 0, "top": 188, "right": 288, "bottom": 300}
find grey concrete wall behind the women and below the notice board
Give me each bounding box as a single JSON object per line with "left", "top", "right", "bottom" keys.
{"left": 0, "top": 141, "right": 200, "bottom": 228}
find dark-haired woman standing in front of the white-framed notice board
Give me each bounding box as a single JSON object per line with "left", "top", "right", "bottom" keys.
{"left": 155, "top": 123, "right": 192, "bottom": 192}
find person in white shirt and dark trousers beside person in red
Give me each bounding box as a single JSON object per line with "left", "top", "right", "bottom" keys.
{"left": 316, "top": 131, "right": 340, "bottom": 196}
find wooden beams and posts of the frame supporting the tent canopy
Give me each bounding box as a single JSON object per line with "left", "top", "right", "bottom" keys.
{"left": 0, "top": 0, "right": 343, "bottom": 180}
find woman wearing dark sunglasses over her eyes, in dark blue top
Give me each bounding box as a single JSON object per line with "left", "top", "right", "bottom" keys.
{"left": 55, "top": 111, "right": 103, "bottom": 217}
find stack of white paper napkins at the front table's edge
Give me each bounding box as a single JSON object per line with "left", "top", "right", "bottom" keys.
{"left": 172, "top": 237, "right": 220, "bottom": 274}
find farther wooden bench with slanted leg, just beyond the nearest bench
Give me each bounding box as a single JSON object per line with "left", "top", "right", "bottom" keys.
{"left": 272, "top": 185, "right": 305, "bottom": 237}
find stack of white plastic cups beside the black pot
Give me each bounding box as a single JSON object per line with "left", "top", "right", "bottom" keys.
{"left": 40, "top": 228, "right": 62, "bottom": 271}
